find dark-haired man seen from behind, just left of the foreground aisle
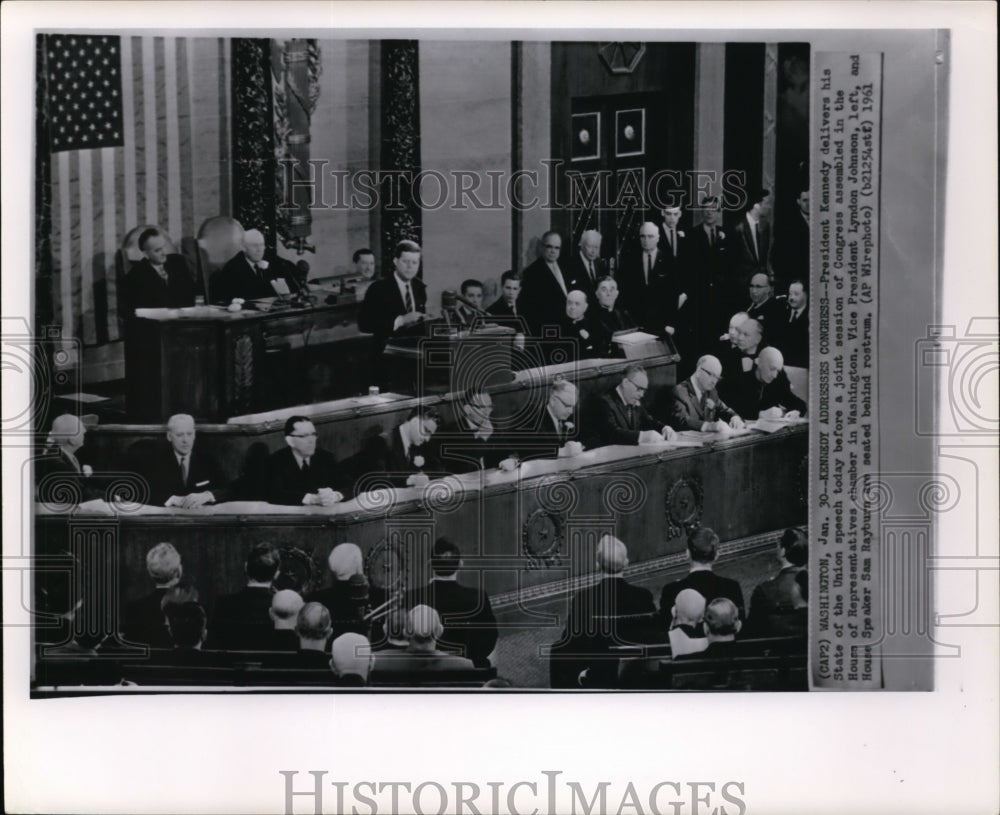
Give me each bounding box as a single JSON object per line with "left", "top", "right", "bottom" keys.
{"left": 404, "top": 538, "right": 498, "bottom": 667}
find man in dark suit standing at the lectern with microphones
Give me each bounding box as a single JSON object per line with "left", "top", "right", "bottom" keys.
{"left": 358, "top": 236, "right": 427, "bottom": 354}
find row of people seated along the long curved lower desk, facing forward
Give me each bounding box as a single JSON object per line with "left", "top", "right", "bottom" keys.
{"left": 36, "top": 346, "right": 806, "bottom": 509}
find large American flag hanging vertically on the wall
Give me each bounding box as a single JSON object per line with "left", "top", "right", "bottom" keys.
{"left": 39, "top": 34, "right": 230, "bottom": 345}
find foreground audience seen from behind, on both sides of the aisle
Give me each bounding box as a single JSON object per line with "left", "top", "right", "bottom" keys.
{"left": 36, "top": 528, "right": 808, "bottom": 687}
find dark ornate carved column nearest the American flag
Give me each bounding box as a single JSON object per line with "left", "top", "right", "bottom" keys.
{"left": 232, "top": 38, "right": 275, "bottom": 249}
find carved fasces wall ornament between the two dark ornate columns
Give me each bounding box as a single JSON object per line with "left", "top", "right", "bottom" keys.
{"left": 271, "top": 39, "right": 323, "bottom": 255}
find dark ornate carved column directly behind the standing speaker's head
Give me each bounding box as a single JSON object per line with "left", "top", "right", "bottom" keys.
{"left": 379, "top": 40, "right": 423, "bottom": 268}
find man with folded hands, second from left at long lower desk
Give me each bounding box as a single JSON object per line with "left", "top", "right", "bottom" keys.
{"left": 135, "top": 413, "right": 233, "bottom": 509}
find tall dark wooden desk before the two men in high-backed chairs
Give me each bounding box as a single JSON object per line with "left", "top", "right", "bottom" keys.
{"left": 125, "top": 300, "right": 372, "bottom": 423}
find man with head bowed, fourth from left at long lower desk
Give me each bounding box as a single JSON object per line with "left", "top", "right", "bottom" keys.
{"left": 355, "top": 405, "right": 444, "bottom": 492}
